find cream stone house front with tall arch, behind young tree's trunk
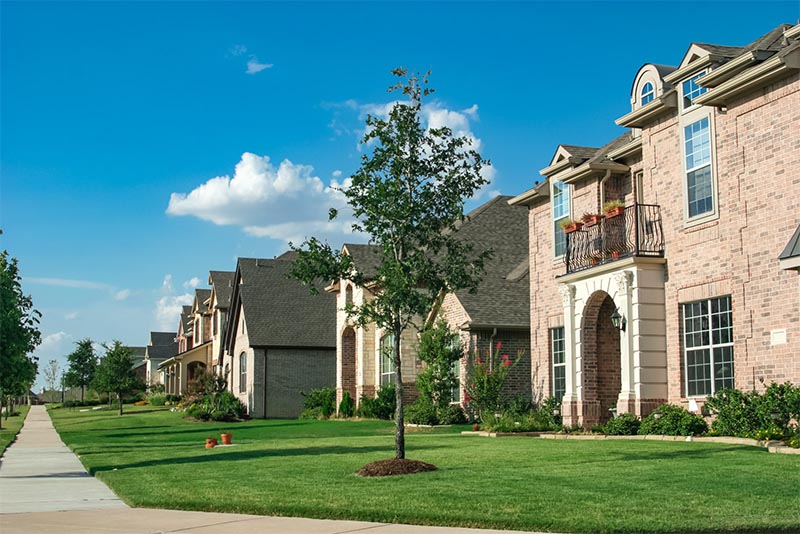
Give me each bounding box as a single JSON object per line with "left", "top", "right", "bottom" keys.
{"left": 325, "top": 243, "right": 422, "bottom": 406}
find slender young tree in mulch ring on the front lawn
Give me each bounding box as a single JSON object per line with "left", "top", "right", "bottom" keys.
{"left": 292, "top": 69, "right": 490, "bottom": 459}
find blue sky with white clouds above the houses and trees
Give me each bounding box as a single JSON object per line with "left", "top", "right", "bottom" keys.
{"left": 0, "top": 0, "right": 800, "bottom": 392}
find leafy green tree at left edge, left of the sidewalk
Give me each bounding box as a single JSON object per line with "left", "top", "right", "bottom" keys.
{"left": 0, "top": 250, "right": 42, "bottom": 432}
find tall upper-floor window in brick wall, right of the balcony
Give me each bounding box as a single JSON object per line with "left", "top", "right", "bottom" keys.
{"left": 683, "top": 117, "right": 714, "bottom": 219}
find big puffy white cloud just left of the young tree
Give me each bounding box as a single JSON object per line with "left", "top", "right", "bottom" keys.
{"left": 167, "top": 152, "right": 350, "bottom": 245}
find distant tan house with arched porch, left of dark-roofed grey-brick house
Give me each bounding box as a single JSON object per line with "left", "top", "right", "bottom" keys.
{"left": 160, "top": 289, "right": 212, "bottom": 395}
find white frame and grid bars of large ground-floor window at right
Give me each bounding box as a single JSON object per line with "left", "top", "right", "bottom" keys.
{"left": 681, "top": 295, "right": 736, "bottom": 398}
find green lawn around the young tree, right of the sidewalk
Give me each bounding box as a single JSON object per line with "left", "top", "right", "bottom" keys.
{"left": 51, "top": 407, "right": 800, "bottom": 532}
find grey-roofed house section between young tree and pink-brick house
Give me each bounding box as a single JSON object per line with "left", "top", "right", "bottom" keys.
{"left": 428, "top": 196, "right": 532, "bottom": 402}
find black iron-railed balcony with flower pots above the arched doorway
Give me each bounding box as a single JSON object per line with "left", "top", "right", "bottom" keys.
{"left": 564, "top": 204, "right": 664, "bottom": 274}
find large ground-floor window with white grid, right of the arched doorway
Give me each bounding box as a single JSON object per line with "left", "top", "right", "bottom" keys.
{"left": 682, "top": 296, "right": 734, "bottom": 397}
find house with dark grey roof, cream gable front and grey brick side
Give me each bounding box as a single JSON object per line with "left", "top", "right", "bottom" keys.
{"left": 224, "top": 253, "right": 336, "bottom": 417}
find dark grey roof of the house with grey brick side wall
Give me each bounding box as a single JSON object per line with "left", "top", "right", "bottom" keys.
{"left": 232, "top": 258, "right": 336, "bottom": 348}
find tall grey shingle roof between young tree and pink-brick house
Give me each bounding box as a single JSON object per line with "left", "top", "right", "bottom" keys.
{"left": 454, "top": 196, "right": 530, "bottom": 328}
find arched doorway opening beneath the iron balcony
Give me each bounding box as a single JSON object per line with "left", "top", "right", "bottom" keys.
{"left": 581, "top": 291, "right": 622, "bottom": 428}
